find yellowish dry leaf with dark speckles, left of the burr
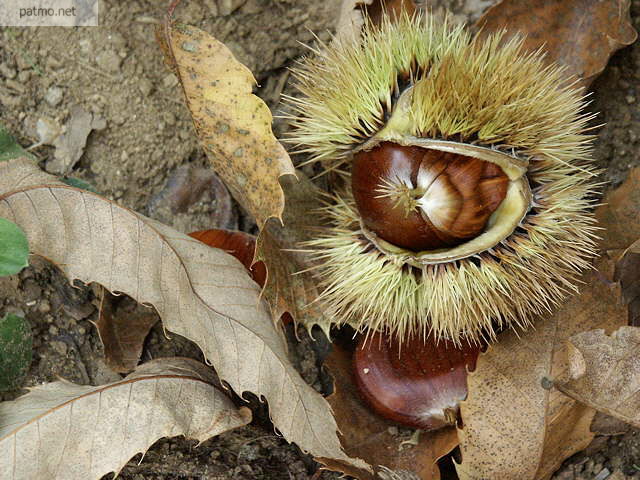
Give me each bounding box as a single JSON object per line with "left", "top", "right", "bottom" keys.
{"left": 158, "top": 19, "right": 294, "bottom": 228}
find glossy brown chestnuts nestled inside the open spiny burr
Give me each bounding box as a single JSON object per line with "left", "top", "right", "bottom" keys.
{"left": 351, "top": 142, "right": 509, "bottom": 252}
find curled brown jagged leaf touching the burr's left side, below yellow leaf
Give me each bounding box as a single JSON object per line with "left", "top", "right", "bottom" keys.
{"left": 256, "top": 172, "right": 331, "bottom": 337}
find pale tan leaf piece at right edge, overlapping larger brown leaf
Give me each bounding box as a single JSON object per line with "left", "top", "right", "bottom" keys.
{"left": 555, "top": 326, "right": 640, "bottom": 428}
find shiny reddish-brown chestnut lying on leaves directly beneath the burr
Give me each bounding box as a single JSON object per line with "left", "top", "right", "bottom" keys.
{"left": 353, "top": 333, "right": 480, "bottom": 430}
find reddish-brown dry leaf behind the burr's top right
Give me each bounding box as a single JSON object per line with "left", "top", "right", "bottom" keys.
{"left": 476, "top": 0, "right": 637, "bottom": 87}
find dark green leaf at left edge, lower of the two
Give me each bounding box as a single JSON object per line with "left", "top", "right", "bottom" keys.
{"left": 0, "top": 313, "right": 33, "bottom": 391}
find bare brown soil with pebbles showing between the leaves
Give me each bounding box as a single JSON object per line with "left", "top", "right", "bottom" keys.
{"left": 0, "top": 0, "right": 640, "bottom": 480}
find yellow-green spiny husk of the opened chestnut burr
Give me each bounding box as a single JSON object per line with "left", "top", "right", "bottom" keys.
{"left": 291, "top": 16, "right": 597, "bottom": 340}
